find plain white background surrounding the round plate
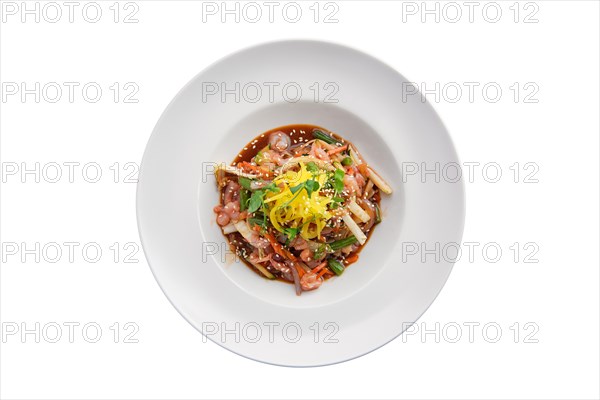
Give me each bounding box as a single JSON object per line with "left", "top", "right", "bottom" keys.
{"left": 0, "top": 1, "right": 600, "bottom": 399}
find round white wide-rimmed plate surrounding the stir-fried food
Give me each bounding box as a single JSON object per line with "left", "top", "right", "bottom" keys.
{"left": 137, "top": 41, "right": 465, "bottom": 366}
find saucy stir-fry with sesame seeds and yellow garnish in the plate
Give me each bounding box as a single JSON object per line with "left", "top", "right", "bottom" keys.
{"left": 214, "top": 125, "right": 392, "bottom": 295}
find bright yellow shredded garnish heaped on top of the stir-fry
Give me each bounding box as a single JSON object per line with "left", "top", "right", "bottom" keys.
{"left": 265, "top": 163, "right": 332, "bottom": 239}
